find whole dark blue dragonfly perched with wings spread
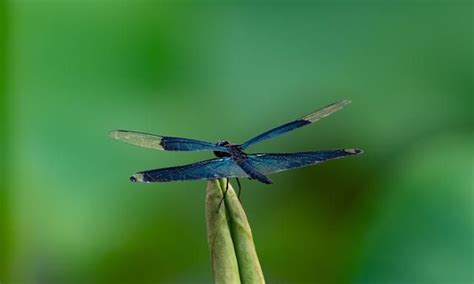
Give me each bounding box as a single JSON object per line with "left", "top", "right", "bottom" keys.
{"left": 110, "top": 100, "right": 363, "bottom": 195}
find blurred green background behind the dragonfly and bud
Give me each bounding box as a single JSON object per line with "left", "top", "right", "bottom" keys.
{"left": 0, "top": 0, "right": 474, "bottom": 284}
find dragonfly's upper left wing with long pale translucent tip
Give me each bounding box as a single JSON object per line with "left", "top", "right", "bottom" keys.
{"left": 110, "top": 130, "right": 229, "bottom": 152}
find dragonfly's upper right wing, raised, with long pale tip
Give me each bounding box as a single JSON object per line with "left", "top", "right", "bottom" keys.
{"left": 242, "top": 100, "right": 351, "bottom": 149}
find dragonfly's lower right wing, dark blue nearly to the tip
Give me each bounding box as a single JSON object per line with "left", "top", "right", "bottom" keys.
{"left": 247, "top": 149, "right": 362, "bottom": 174}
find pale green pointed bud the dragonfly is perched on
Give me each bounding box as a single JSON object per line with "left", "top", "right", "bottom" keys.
{"left": 206, "top": 179, "right": 265, "bottom": 283}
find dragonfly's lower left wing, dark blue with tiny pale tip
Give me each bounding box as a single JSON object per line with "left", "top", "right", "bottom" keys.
{"left": 130, "top": 157, "right": 248, "bottom": 182}
